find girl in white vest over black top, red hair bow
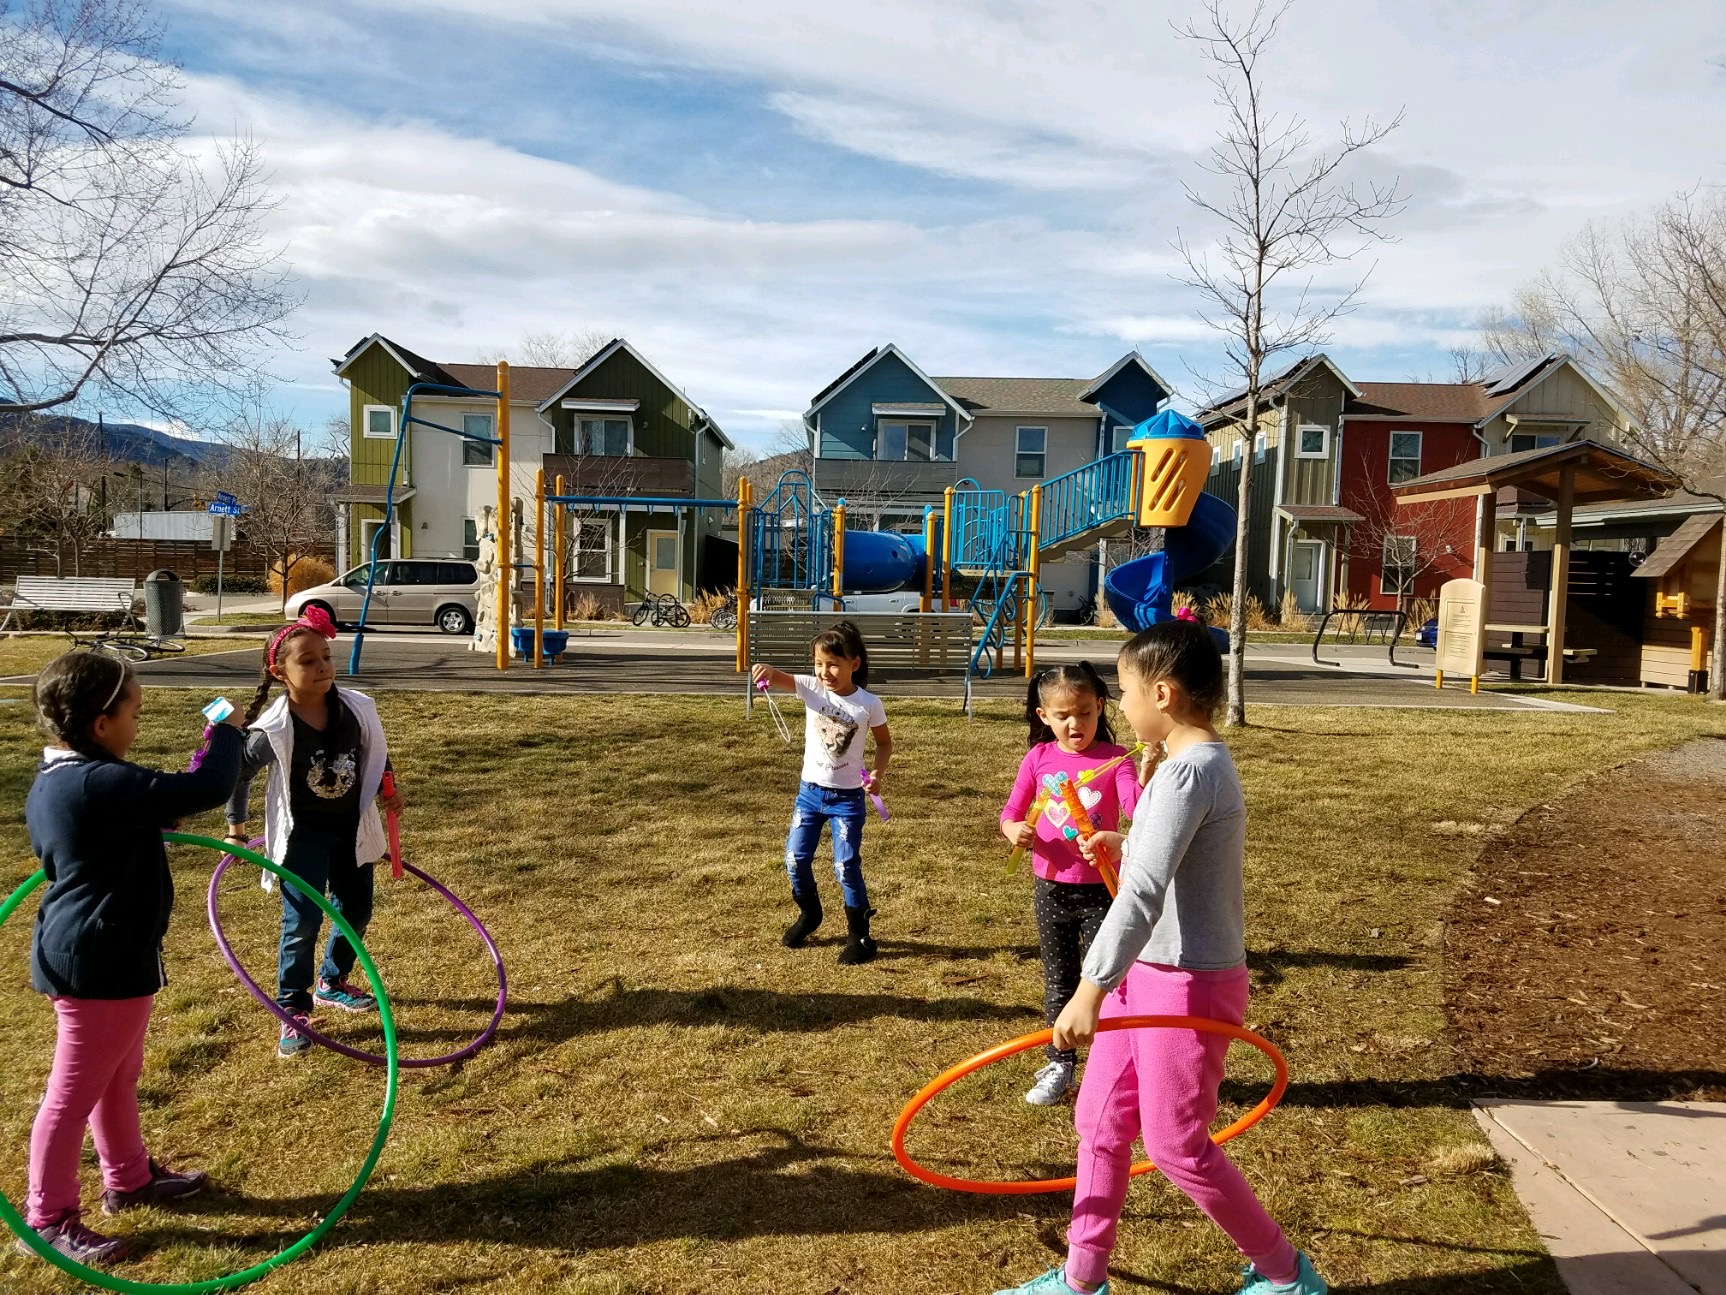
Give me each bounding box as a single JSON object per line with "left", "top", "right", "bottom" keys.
{"left": 228, "top": 608, "right": 402, "bottom": 1057}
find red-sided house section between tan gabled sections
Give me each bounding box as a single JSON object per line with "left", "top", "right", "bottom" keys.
{"left": 1338, "top": 382, "right": 1498, "bottom": 610}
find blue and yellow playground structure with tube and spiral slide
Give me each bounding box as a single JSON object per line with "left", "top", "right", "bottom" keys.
{"left": 737, "top": 411, "right": 1236, "bottom": 677}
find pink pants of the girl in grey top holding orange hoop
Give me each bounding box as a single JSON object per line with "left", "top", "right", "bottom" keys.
{"left": 1067, "top": 963, "right": 1300, "bottom": 1285}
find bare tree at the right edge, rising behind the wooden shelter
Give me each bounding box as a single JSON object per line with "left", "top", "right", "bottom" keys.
{"left": 1484, "top": 188, "right": 1726, "bottom": 701}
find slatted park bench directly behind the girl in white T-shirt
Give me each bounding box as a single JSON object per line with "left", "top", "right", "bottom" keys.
{"left": 744, "top": 611, "right": 972, "bottom": 715}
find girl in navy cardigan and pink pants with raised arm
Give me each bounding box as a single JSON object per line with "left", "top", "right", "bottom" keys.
{"left": 24, "top": 653, "right": 240, "bottom": 1264}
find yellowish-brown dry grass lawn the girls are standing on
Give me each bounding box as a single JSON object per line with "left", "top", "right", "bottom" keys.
{"left": 0, "top": 689, "right": 1726, "bottom": 1295}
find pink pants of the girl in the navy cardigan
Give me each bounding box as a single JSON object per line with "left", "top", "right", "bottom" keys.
{"left": 24, "top": 996, "right": 154, "bottom": 1228}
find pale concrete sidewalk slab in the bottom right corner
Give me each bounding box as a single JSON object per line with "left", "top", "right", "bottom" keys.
{"left": 1474, "top": 1102, "right": 1726, "bottom": 1295}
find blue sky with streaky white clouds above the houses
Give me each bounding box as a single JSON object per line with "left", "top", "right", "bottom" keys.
{"left": 164, "top": 0, "right": 1726, "bottom": 445}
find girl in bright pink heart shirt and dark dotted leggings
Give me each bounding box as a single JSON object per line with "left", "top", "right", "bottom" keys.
{"left": 1001, "top": 661, "right": 1139, "bottom": 1107}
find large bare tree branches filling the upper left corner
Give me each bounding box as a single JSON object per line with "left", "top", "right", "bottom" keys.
{"left": 0, "top": 0, "right": 297, "bottom": 423}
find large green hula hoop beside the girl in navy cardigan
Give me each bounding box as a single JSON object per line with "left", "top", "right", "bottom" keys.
{"left": 0, "top": 832, "right": 400, "bottom": 1295}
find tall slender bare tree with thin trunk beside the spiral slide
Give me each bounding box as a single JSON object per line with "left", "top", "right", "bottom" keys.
{"left": 1175, "top": 0, "right": 1403, "bottom": 725}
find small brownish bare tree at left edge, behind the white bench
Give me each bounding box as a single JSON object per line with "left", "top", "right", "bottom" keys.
{"left": 0, "top": 414, "right": 113, "bottom": 575}
